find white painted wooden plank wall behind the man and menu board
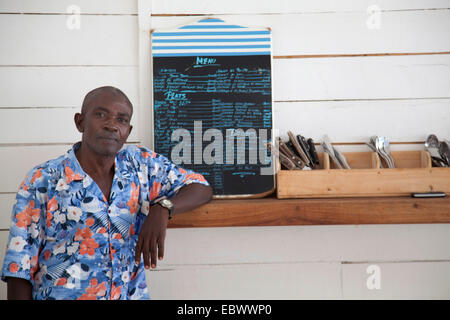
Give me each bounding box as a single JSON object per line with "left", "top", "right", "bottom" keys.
{"left": 0, "top": 0, "right": 450, "bottom": 299}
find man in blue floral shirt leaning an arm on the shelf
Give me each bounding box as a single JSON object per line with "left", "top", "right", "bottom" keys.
{"left": 2, "top": 87, "right": 212, "bottom": 300}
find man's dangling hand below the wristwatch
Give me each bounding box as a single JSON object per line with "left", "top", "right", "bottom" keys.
{"left": 134, "top": 204, "right": 169, "bottom": 269}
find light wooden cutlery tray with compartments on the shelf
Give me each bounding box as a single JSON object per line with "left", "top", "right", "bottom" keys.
{"left": 277, "top": 151, "right": 450, "bottom": 199}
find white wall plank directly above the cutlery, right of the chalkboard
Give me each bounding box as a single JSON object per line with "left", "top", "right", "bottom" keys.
{"left": 274, "top": 98, "right": 450, "bottom": 142}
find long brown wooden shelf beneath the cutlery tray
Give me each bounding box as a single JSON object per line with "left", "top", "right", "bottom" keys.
{"left": 168, "top": 196, "right": 450, "bottom": 228}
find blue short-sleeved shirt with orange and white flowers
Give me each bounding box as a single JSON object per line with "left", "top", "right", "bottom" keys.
{"left": 1, "top": 143, "right": 208, "bottom": 300}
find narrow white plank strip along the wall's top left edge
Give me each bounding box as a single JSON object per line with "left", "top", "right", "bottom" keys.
{"left": 0, "top": 0, "right": 137, "bottom": 14}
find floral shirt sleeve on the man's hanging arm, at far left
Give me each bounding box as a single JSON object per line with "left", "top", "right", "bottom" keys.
{"left": 1, "top": 168, "right": 46, "bottom": 282}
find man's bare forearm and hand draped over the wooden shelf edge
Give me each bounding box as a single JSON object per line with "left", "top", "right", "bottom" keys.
{"left": 135, "top": 183, "right": 213, "bottom": 269}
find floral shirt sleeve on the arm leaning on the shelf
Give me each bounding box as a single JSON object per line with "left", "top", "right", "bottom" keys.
{"left": 142, "top": 150, "right": 209, "bottom": 205}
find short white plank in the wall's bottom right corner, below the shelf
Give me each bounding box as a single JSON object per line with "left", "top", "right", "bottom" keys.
{"left": 342, "top": 262, "right": 450, "bottom": 299}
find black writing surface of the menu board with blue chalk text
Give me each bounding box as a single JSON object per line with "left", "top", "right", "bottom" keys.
{"left": 153, "top": 55, "right": 274, "bottom": 195}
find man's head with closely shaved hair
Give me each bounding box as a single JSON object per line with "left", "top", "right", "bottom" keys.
{"left": 75, "top": 86, "right": 133, "bottom": 156}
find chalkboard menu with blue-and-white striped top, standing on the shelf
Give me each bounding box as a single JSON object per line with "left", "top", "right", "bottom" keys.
{"left": 152, "top": 18, "right": 275, "bottom": 198}
